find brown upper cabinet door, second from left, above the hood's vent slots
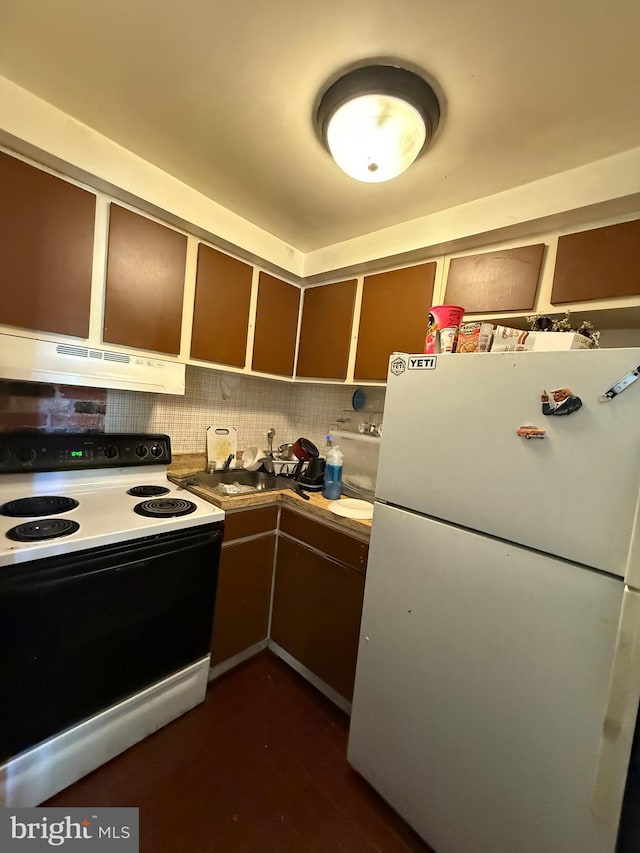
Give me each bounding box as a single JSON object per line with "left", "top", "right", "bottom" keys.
{"left": 103, "top": 204, "right": 187, "bottom": 355}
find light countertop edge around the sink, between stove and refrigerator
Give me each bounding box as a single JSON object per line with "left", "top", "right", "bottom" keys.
{"left": 168, "top": 453, "right": 371, "bottom": 539}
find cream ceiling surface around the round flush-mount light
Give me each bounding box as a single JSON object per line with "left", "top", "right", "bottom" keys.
{"left": 0, "top": 0, "right": 640, "bottom": 252}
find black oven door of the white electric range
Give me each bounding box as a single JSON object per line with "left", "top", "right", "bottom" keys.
{"left": 0, "top": 524, "right": 222, "bottom": 762}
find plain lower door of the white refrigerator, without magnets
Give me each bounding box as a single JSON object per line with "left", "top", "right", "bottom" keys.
{"left": 348, "top": 504, "right": 624, "bottom": 853}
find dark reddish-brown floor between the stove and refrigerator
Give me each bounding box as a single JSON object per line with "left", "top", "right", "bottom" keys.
{"left": 45, "top": 652, "right": 432, "bottom": 853}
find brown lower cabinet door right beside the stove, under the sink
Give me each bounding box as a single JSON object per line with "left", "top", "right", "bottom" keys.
{"left": 211, "top": 533, "right": 276, "bottom": 665}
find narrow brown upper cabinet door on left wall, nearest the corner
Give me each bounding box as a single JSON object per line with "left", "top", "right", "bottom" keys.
{"left": 251, "top": 272, "right": 300, "bottom": 376}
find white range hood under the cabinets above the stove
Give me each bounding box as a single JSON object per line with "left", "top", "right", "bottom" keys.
{"left": 0, "top": 333, "right": 185, "bottom": 394}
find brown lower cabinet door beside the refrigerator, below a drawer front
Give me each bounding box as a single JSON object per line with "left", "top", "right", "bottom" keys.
{"left": 271, "top": 536, "right": 365, "bottom": 701}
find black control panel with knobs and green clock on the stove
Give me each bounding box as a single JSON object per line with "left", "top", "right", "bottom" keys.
{"left": 0, "top": 432, "right": 171, "bottom": 474}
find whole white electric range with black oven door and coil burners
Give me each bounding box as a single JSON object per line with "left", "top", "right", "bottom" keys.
{"left": 0, "top": 432, "right": 224, "bottom": 806}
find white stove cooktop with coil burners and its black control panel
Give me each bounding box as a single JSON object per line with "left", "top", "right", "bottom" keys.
{"left": 0, "top": 433, "right": 224, "bottom": 566}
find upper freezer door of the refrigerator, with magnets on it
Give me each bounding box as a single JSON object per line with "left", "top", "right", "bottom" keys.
{"left": 376, "top": 349, "right": 640, "bottom": 577}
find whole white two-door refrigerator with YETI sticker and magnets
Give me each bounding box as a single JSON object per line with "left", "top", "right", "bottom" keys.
{"left": 348, "top": 349, "right": 640, "bottom": 853}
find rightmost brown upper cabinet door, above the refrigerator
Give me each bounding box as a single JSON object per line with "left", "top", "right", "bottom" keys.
{"left": 551, "top": 219, "right": 640, "bottom": 304}
